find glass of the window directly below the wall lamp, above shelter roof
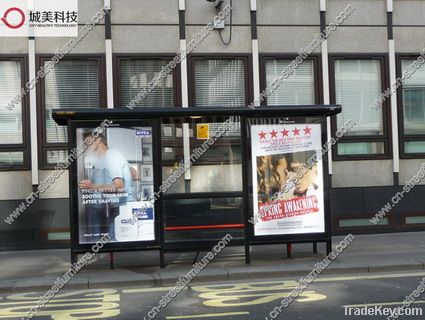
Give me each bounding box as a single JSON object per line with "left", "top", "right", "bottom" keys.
{"left": 194, "top": 59, "right": 246, "bottom": 107}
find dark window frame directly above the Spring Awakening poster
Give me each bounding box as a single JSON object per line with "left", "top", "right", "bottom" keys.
{"left": 260, "top": 53, "right": 323, "bottom": 106}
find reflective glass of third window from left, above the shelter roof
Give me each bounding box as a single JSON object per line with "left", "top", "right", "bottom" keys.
{"left": 120, "top": 59, "right": 174, "bottom": 107}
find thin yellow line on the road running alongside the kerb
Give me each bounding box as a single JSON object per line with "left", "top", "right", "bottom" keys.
{"left": 122, "top": 271, "right": 425, "bottom": 293}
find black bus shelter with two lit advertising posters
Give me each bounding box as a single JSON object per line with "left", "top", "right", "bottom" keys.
{"left": 53, "top": 105, "right": 341, "bottom": 267}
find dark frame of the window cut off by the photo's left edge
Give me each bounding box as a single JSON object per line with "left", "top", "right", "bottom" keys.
{"left": 0, "top": 54, "right": 29, "bottom": 171}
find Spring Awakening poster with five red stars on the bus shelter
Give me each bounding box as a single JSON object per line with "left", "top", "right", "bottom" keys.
{"left": 251, "top": 123, "right": 325, "bottom": 236}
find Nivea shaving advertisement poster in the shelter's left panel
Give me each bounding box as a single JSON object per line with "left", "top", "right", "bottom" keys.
{"left": 77, "top": 127, "right": 155, "bottom": 244}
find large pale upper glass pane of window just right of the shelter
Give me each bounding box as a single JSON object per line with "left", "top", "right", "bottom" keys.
{"left": 335, "top": 60, "right": 383, "bottom": 135}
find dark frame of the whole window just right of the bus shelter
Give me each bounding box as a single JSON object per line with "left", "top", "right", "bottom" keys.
{"left": 329, "top": 53, "right": 392, "bottom": 161}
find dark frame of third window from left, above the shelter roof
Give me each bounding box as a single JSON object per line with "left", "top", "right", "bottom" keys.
{"left": 112, "top": 53, "right": 182, "bottom": 108}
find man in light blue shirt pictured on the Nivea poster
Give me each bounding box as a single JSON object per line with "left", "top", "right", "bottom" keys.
{"left": 79, "top": 132, "right": 135, "bottom": 242}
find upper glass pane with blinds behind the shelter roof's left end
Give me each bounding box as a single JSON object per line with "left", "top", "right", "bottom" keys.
{"left": 44, "top": 60, "right": 100, "bottom": 143}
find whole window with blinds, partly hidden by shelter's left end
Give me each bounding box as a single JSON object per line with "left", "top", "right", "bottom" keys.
{"left": 41, "top": 57, "right": 103, "bottom": 167}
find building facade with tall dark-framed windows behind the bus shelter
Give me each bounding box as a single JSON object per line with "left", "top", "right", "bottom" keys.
{"left": 0, "top": 0, "right": 425, "bottom": 250}
